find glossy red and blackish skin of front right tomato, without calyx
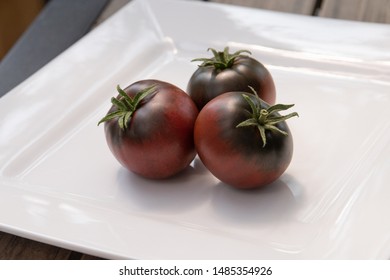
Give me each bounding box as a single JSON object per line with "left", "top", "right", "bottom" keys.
{"left": 194, "top": 92, "right": 293, "bottom": 188}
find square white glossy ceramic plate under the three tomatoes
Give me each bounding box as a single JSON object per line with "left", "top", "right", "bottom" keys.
{"left": 0, "top": 0, "right": 390, "bottom": 259}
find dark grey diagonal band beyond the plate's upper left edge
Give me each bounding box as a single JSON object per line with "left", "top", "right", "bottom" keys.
{"left": 0, "top": 0, "right": 109, "bottom": 97}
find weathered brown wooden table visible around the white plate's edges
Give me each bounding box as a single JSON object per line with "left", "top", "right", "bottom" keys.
{"left": 0, "top": 0, "right": 390, "bottom": 260}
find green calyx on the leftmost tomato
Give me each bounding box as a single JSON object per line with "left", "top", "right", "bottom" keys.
{"left": 98, "top": 85, "right": 156, "bottom": 130}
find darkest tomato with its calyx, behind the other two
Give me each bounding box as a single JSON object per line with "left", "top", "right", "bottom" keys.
{"left": 187, "top": 47, "right": 276, "bottom": 110}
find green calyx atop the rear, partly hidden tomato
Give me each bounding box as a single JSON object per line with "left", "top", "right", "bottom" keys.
{"left": 191, "top": 47, "right": 251, "bottom": 70}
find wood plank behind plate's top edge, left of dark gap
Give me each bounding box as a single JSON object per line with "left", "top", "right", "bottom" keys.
{"left": 210, "top": 0, "right": 316, "bottom": 15}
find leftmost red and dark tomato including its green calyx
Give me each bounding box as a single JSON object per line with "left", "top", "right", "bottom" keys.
{"left": 99, "top": 80, "right": 198, "bottom": 179}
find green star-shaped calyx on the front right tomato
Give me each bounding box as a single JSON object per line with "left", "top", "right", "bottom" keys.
{"left": 236, "top": 89, "right": 298, "bottom": 147}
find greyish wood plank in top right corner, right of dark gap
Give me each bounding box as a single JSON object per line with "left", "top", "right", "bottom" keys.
{"left": 318, "top": 0, "right": 390, "bottom": 23}
